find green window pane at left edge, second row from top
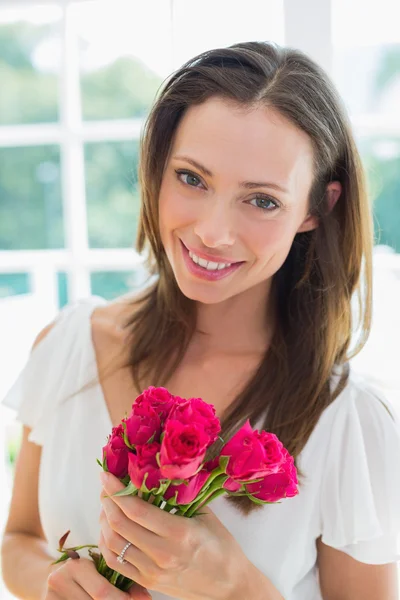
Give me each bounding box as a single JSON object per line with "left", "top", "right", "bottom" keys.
{"left": 0, "top": 146, "right": 64, "bottom": 250}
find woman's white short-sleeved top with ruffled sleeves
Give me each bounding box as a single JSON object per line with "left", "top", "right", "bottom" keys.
{"left": 3, "top": 296, "right": 400, "bottom": 600}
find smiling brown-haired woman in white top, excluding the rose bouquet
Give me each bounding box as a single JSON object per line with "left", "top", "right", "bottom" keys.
{"left": 3, "top": 42, "right": 400, "bottom": 600}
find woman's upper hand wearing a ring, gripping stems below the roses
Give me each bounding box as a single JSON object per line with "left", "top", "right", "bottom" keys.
{"left": 99, "top": 473, "right": 250, "bottom": 600}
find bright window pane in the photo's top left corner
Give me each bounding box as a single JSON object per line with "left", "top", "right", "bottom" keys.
{"left": 0, "top": 5, "right": 61, "bottom": 125}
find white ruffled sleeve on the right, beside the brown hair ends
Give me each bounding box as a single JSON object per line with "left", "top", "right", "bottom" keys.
{"left": 321, "top": 382, "right": 400, "bottom": 564}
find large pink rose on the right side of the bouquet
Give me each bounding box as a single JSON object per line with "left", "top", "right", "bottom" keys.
{"left": 221, "top": 420, "right": 285, "bottom": 481}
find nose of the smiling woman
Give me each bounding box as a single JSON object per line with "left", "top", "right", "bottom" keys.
{"left": 194, "top": 203, "right": 234, "bottom": 248}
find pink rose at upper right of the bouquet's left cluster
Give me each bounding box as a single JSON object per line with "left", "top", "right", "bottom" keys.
{"left": 169, "top": 397, "right": 221, "bottom": 444}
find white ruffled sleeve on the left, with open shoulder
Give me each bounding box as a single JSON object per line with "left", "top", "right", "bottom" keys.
{"left": 2, "top": 300, "right": 98, "bottom": 446}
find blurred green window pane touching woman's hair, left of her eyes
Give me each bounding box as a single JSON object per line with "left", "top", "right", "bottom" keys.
{"left": 85, "top": 141, "right": 139, "bottom": 248}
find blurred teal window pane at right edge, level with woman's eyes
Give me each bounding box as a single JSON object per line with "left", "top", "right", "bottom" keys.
{"left": 358, "top": 137, "right": 400, "bottom": 252}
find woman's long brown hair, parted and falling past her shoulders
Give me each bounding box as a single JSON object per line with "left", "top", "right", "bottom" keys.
{"left": 100, "top": 42, "right": 373, "bottom": 514}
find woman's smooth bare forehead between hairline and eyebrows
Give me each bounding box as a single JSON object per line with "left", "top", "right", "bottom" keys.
{"left": 170, "top": 99, "right": 313, "bottom": 199}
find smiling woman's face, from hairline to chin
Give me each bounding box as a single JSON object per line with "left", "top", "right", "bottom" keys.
{"left": 159, "top": 98, "right": 318, "bottom": 304}
